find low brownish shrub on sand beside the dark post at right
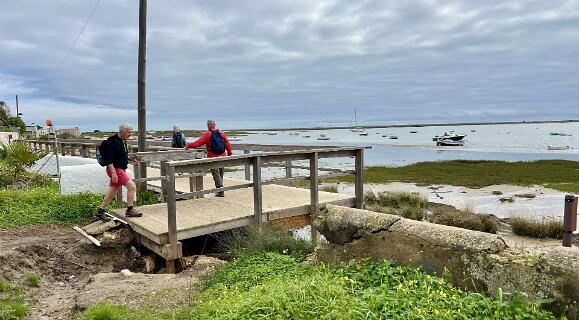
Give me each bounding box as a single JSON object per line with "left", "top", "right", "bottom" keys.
{"left": 508, "top": 217, "right": 563, "bottom": 239}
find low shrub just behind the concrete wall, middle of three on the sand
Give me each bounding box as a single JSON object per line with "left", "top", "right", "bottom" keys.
{"left": 428, "top": 205, "right": 499, "bottom": 233}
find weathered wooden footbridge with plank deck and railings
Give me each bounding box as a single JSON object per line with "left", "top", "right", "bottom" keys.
{"left": 29, "top": 141, "right": 364, "bottom": 272}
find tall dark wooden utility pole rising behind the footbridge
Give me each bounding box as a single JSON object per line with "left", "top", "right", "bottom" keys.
{"left": 137, "top": 0, "right": 147, "bottom": 187}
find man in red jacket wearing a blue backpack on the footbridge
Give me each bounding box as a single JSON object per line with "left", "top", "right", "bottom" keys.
{"left": 185, "top": 120, "right": 233, "bottom": 197}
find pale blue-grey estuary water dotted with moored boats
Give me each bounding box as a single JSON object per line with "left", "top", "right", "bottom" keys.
{"left": 233, "top": 123, "right": 579, "bottom": 166}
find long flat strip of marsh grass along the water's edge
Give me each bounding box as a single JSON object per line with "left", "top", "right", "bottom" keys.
{"left": 332, "top": 160, "right": 579, "bottom": 193}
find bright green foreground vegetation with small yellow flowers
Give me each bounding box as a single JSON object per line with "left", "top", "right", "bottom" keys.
{"left": 79, "top": 252, "right": 555, "bottom": 320}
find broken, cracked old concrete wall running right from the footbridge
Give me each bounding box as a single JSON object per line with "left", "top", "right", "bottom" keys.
{"left": 315, "top": 205, "right": 579, "bottom": 318}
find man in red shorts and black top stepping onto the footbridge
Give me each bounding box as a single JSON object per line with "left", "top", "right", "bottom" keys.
{"left": 95, "top": 123, "right": 143, "bottom": 220}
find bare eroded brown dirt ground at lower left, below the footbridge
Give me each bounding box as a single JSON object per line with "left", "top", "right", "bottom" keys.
{"left": 0, "top": 226, "right": 224, "bottom": 320}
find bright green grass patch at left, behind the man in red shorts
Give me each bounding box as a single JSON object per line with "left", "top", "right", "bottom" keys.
{"left": 0, "top": 187, "right": 102, "bottom": 227}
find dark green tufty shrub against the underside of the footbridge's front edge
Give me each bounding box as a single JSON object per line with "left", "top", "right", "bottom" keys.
{"left": 217, "top": 226, "right": 313, "bottom": 260}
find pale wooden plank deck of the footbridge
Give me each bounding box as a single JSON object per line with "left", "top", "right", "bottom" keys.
{"left": 113, "top": 177, "right": 355, "bottom": 245}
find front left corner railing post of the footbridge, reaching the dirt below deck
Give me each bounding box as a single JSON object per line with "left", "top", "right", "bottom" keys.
{"left": 161, "top": 162, "right": 181, "bottom": 273}
